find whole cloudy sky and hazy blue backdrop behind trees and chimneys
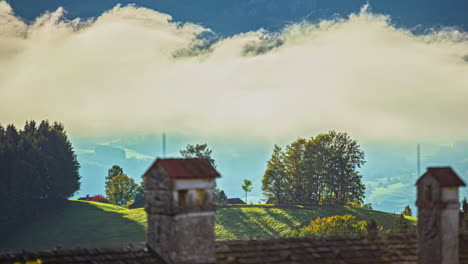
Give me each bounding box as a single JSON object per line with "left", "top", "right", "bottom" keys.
{"left": 0, "top": 0, "right": 468, "bottom": 211}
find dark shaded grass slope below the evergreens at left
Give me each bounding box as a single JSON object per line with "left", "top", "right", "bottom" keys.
{"left": 0, "top": 201, "right": 145, "bottom": 250}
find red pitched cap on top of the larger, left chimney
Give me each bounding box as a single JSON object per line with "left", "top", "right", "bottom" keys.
{"left": 143, "top": 158, "right": 220, "bottom": 179}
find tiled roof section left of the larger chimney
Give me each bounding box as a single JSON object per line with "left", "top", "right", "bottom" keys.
{"left": 0, "top": 247, "right": 165, "bottom": 264}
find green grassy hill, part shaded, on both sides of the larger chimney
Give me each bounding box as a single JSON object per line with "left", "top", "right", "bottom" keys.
{"left": 0, "top": 201, "right": 416, "bottom": 249}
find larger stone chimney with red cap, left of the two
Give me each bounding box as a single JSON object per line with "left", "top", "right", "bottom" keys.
{"left": 143, "top": 158, "right": 220, "bottom": 264}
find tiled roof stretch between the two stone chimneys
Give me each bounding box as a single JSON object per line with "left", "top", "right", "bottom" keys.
{"left": 216, "top": 234, "right": 417, "bottom": 264}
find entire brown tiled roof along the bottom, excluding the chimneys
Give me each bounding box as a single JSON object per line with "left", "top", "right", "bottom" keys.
{"left": 0, "top": 233, "right": 468, "bottom": 264}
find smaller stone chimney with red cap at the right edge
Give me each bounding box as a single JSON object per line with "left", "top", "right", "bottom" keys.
{"left": 416, "top": 167, "right": 465, "bottom": 264}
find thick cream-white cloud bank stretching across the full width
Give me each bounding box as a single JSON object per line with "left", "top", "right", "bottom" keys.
{"left": 0, "top": 1, "right": 468, "bottom": 141}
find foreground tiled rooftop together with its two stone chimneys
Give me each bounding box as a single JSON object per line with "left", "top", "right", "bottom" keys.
{"left": 0, "top": 164, "right": 468, "bottom": 264}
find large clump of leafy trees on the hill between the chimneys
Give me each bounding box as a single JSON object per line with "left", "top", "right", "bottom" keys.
{"left": 262, "top": 131, "right": 365, "bottom": 205}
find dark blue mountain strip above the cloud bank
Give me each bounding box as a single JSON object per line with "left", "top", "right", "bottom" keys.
{"left": 8, "top": 0, "right": 468, "bottom": 35}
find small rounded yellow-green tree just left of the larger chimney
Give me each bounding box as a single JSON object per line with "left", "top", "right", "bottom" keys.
{"left": 106, "top": 174, "right": 138, "bottom": 206}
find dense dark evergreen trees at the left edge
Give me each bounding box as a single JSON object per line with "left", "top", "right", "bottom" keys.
{"left": 0, "top": 121, "right": 80, "bottom": 235}
